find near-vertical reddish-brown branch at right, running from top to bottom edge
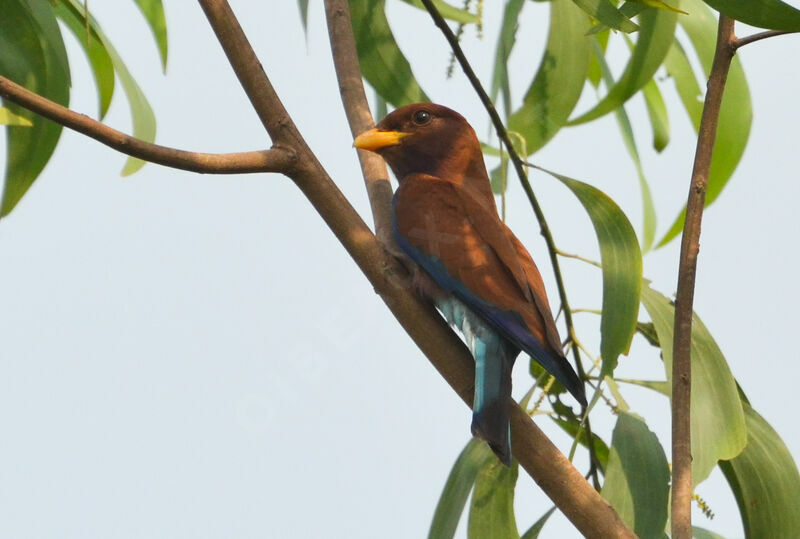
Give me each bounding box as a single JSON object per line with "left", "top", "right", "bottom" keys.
{"left": 672, "top": 14, "right": 736, "bottom": 539}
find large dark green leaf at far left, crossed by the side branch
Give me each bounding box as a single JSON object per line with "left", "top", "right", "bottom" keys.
{"left": 0, "top": 0, "right": 70, "bottom": 217}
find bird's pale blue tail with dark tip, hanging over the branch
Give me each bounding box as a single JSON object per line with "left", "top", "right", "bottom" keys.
{"left": 472, "top": 336, "right": 519, "bottom": 466}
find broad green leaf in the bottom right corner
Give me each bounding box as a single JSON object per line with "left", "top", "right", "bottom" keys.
{"left": 719, "top": 403, "right": 800, "bottom": 538}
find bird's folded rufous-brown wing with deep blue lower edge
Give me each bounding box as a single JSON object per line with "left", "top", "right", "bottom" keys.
{"left": 393, "top": 175, "right": 585, "bottom": 402}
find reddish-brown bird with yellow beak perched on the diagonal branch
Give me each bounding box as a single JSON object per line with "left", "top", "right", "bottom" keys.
{"left": 353, "top": 103, "right": 586, "bottom": 466}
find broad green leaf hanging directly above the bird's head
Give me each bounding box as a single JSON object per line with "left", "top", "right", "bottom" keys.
{"left": 350, "top": 0, "right": 429, "bottom": 107}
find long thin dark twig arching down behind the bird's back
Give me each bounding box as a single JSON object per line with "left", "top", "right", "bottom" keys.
{"left": 422, "top": 0, "right": 600, "bottom": 490}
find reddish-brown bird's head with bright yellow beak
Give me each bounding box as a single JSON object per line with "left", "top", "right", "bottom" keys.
{"left": 353, "top": 103, "right": 486, "bottom": 182}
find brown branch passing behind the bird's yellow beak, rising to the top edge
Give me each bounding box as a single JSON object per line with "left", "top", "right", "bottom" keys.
{"left": 325, "top": 0, "right": 394, "bottom": 245}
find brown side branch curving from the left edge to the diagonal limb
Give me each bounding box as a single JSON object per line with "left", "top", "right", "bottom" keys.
{"left": 0, "top": 77, "right": 293, "bottom": 174}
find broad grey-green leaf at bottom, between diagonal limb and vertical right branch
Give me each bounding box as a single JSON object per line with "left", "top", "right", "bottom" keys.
{"left": 600, "top": 412, "right": 669, "bottom": 539}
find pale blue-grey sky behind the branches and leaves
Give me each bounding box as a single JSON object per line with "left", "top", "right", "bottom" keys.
{"left": 0, "top": 0, "right": 800, "bottom": 539}
